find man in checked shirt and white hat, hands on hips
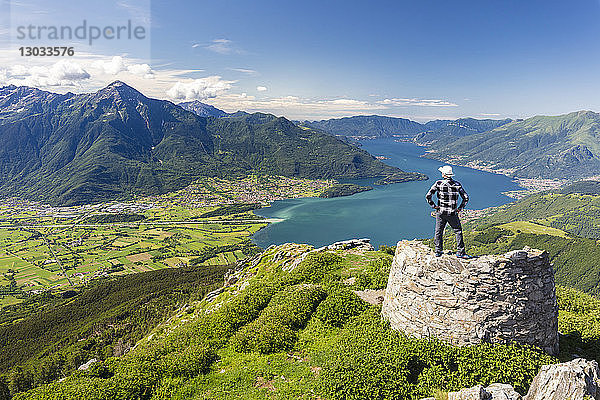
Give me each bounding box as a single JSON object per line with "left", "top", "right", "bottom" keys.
{"left": 425, "top": 165, "right": 471, "bottom": 259}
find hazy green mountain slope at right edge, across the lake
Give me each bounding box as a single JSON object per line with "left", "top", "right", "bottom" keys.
{"left": 429, "top": 111, "right": 600, "bottom": 178}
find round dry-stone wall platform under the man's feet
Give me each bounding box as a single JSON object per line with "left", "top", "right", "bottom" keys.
{"left": 382, "top": 241, "right": 558, "bottom": 355}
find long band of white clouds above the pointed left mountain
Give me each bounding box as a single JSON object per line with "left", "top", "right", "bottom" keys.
{"left": 0, "top": 49, "right": 458, "bottom": 120}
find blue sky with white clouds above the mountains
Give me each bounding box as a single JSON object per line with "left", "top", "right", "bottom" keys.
{"left": 0, "top": 0, "right": 600, "bottom": 121}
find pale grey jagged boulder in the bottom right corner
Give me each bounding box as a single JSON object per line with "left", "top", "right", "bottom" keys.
{"left": 525, "top": 358, "right": 600, "bottom": 400}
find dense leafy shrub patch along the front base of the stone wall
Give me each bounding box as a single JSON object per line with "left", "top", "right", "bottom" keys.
{"left": 319, "top": 307, "right": 556, "bottom": 400}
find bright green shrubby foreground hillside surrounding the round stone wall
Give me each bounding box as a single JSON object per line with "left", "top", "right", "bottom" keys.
{"left": 4, "top": 244, "right": 598, "bottom": 400}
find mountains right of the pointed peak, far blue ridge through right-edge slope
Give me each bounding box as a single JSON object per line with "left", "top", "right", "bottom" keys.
{"left": 300, "top": 111, "right": 600, "bottom": 179}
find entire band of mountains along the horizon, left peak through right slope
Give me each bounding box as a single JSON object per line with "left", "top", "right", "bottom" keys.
{"left": 0, "top": 81, "right": 600, "bottom": 204}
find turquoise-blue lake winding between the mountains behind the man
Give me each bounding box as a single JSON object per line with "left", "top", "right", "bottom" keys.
{"left": 253, "top": 139, "right": 519, "bottom": 248}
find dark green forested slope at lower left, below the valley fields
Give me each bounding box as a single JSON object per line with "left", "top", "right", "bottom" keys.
{"left": 0, "top": 266, "right": 227, "bottom": 397}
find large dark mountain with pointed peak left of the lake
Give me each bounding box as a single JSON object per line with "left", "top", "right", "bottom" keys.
{"left": 0, "top": 81, "right": 426, "bottom": 205}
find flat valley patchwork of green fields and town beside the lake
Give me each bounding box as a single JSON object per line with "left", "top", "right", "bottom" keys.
{"left": 0, "top": 176, "right": 335, "bottom": 305}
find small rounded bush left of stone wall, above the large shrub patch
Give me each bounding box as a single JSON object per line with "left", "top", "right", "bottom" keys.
{"left": 315, "top": 285, "right": 367, "bottom": 327}
